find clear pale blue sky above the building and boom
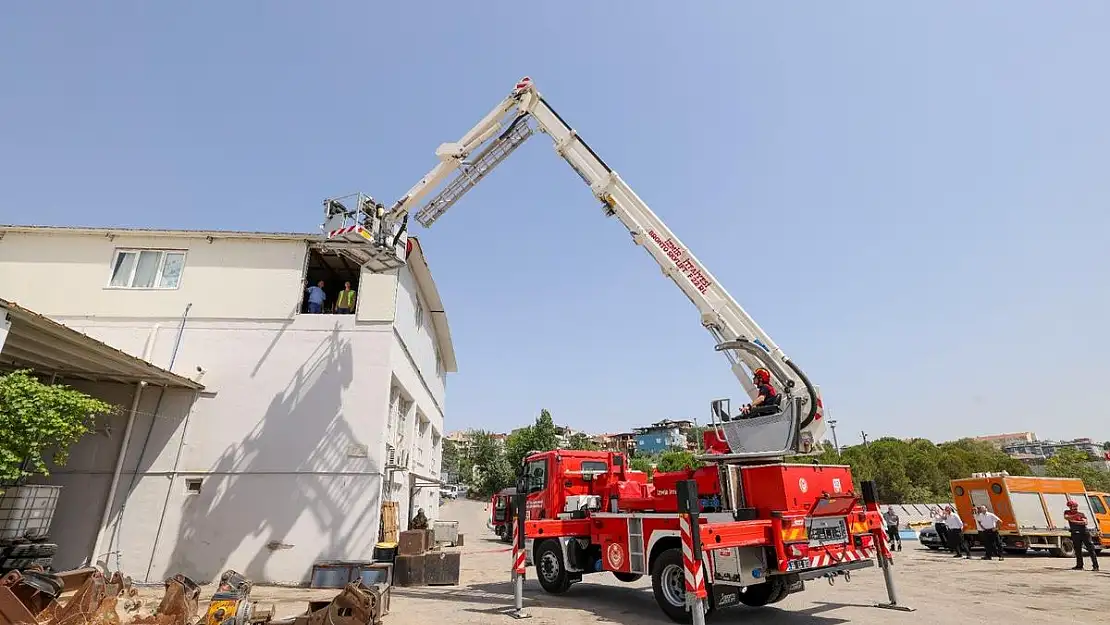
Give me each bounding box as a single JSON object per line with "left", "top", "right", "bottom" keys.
{"left": 0, "top": 1, "right": 1110, "bottom": 444}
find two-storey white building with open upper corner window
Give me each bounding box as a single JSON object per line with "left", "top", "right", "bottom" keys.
{"left": 0, "top": 226, "right": 455, "bottom": 583}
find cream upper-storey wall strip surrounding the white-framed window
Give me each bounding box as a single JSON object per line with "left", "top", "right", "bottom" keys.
{"left": 0, "top": 230, "right": 307, "bottom": 320}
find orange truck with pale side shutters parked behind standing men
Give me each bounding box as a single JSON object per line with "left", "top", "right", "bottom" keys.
{"left": 951, "top": 472, "right": 1099, "bottom": 557}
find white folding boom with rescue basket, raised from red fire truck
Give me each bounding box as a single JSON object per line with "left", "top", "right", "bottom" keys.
{"left": 321, "top": 77, "right": 825, "bottom": 461}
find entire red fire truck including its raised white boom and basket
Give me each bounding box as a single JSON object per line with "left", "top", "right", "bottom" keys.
{"left": 322, "top": 78, "right": 896, "bottom": 621}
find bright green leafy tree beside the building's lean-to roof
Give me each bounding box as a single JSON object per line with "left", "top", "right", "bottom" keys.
{"left": 0, "top": 371, "right": 115, "bottom": 482}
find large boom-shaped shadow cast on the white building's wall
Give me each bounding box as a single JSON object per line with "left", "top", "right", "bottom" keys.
{"left": 159, "top": 332, "right": 381, "bottom": 582}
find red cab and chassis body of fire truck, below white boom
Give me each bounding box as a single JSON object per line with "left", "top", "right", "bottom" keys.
{"left": 517, "top": 450, "right": 889, "bottom": 623}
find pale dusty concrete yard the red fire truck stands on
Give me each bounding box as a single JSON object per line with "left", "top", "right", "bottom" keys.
{"left": 132, "top": 501, "right": 1110, "bottom": 625}
